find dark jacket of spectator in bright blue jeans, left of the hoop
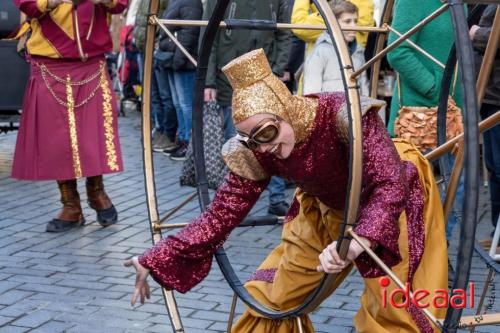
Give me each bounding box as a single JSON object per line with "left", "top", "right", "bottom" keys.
{"left": 160, "top": 0, "right": 203, "bottom": 71}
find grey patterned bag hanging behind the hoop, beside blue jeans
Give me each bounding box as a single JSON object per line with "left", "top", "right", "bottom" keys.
{"left": 180, "top": 101, "right": 228, "bottom": 190}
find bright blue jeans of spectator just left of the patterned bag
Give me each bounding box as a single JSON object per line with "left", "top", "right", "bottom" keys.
{"left": 168, "top": 71, "right": 196, "bottom": 142}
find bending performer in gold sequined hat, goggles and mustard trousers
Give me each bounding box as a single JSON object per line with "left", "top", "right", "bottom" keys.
{"left": 125, "top": 50, "right": 447, "bottom": 333}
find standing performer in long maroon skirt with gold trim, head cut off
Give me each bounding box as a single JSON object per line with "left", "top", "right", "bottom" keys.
{"left": 12, "top": 0, "right": 128, "bottom": 232}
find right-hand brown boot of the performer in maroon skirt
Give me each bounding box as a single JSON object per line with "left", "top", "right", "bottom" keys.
{"left": 86, "top": 176, "right": 118, "bottom": 227}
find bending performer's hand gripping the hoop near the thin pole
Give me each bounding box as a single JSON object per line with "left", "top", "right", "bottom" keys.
{"left": 316, "top": 237, "right": 371, "bottom": 273}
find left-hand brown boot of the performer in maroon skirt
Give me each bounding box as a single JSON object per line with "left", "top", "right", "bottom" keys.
{"left": 45, "top": 179, "right": 85, "bottom": 232}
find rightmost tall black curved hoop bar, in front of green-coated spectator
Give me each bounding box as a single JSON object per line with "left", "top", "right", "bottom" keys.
{"left": 443, "top": 0, "right": 479, "bottom": 333}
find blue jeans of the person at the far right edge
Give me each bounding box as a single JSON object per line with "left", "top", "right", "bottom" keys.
{"left": 481, "top": 104, "right": 500, "bottom": 231}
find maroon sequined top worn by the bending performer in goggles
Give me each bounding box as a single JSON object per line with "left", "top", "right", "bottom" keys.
{"left": 139, "top": 94, "right": 416, "bottom": 292}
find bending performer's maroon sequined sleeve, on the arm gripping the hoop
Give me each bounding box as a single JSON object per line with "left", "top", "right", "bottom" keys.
{"left": 354, "top": 109, "right": 408, "bottom": 278}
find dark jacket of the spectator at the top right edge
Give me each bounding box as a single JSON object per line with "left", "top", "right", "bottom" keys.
{"left": 472, "top": 5, "right": 500, "bottom": 105}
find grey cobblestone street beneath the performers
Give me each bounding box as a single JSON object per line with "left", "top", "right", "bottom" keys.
{"left": 0, "top": 111, "right": 500, "bottom": 333}
